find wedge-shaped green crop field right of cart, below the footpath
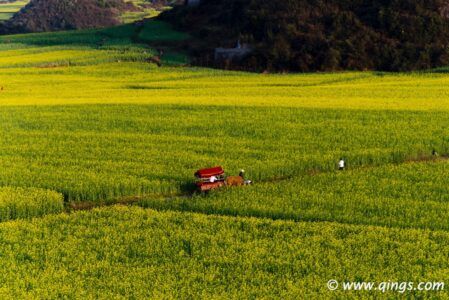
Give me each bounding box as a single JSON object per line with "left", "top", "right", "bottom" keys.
{"left": 141, "top": 161, "right": 449, "bottom": 230}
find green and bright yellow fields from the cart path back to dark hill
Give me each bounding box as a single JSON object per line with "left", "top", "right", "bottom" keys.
{"left": 0, "top": 39, "right": 449, "bottom": 201}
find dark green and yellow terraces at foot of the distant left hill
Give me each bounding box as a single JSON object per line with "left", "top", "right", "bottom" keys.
{"left": 0, "top": 20, "right": 188, "bottom": 67}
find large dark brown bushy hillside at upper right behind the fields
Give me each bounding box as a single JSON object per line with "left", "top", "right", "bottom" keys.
{"left": 162, "top": 0, "right": 449, "bottom": 71}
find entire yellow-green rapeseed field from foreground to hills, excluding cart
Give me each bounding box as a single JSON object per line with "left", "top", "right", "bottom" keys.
{"left": 0, "top": 21, "right": 449, "bottom": 299}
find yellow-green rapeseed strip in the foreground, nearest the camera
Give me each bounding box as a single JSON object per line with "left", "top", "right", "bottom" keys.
{"left": 0, "top": 206, "right": 449, "bottom": 299}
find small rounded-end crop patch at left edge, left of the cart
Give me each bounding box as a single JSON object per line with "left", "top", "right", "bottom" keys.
{"left": 0, "top": 187, "right": 64, "bottom": 222}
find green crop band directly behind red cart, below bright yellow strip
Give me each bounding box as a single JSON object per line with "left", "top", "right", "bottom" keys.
{"left": 0, "top": 104, "right": 449, "bottom": 202}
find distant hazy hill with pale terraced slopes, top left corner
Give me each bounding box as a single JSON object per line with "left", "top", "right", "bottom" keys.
{"left": 0, "top": 0, "right": 183, "bottom": 34}
